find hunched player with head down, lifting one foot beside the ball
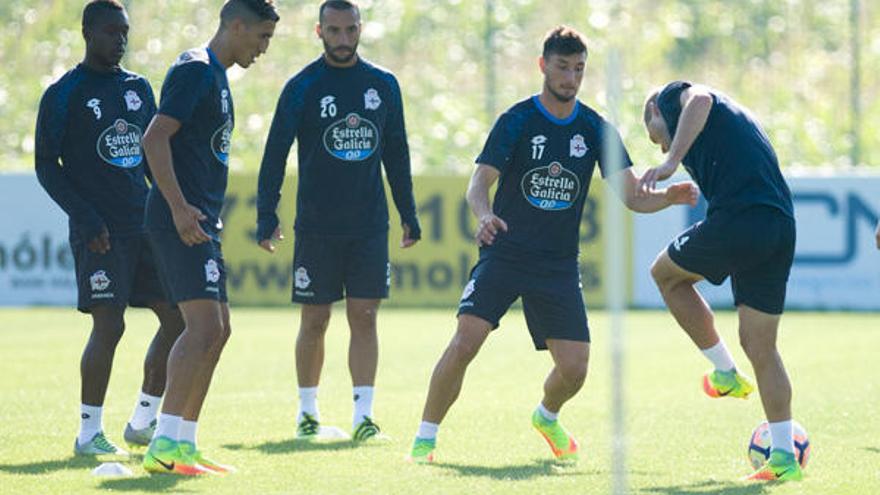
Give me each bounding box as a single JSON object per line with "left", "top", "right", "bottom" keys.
{"left": 640, "top": 81, "right": 801, "bottom": 480}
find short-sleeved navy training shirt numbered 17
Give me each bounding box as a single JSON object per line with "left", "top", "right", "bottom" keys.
{"left": 476, "top": 96, "right": 632, "bottom": 263}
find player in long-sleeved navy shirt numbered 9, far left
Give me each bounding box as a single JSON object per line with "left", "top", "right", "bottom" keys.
{"left": 36, "top": 0, "right": 183, "bottom": 455}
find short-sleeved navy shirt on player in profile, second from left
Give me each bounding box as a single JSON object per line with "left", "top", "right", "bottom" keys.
{"left": 147, "top": 47, "right": 235, "bottom": 240}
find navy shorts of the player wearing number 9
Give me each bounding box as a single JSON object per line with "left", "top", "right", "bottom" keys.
{"left": 70, "top": 234, "right": 168, "bottom": 313}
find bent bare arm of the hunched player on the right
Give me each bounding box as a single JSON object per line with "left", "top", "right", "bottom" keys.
{"left": 639, "top": 86, "right": 712, "bottom": 194}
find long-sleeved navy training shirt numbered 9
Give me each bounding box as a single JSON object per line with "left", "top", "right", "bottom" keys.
{"left": 35, "top": 64, "right": 156, "bottom": 242}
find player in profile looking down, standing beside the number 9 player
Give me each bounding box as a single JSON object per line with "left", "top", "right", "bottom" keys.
{"left": 143, "top": 0, "right": 279, "bottom": 475}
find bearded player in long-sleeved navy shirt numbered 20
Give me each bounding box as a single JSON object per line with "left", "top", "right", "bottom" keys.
{"left": 257, "top": 0, "right": 420, "bottom": 440}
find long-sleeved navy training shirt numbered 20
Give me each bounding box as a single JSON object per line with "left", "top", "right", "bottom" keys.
{"left": 257, "top": 56, "right": 420, "bottom": 240}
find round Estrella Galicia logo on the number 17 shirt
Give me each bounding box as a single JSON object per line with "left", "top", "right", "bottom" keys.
{"left": 522, "top": 162, "right": 581, "bottom": 211}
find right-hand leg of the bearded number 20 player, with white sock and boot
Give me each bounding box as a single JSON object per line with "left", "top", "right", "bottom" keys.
{"left": 345, "top": 297, "right": 381, "bottom": 440}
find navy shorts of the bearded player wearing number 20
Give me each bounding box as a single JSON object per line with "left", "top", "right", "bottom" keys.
{"left": 292, "top": 231, "right": 391, "bottom": 304}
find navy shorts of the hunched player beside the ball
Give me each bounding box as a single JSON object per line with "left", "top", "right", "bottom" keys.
{"left": 667, "top": 206, "right": 795, "bottom": 315}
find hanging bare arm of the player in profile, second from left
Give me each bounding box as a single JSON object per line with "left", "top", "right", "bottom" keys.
{"left": 143, "top": 115, "right": 210, "bottom": 246}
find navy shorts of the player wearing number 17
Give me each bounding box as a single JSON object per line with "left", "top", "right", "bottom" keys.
{"left": 458, "top": 256, "right": 590, "bottom": 350}
